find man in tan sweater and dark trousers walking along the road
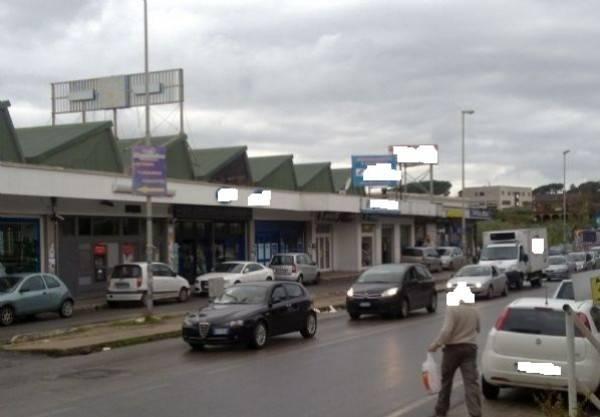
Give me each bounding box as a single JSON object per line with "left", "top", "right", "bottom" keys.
{"left": 428, "top": 300, "right": 481, "bottom": 417}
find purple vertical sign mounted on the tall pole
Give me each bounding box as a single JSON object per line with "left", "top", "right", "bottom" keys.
{"left": 131, "top": 145, "right": 167, "bottom": 196}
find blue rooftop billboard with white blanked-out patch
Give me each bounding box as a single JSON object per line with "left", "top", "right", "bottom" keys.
{"left": 352, "top": 155, "right": 401, "bottom": 187}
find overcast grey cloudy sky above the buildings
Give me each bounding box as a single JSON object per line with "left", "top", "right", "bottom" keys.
{"left": 0, "top": 0, "right": 600, "bottom": 192}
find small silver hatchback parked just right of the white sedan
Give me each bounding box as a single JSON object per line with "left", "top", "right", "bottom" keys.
{"left": 269, "top": 253, "right": 321, "bottom": 284}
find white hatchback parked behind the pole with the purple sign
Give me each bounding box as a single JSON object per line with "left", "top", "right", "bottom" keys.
{"left": 106, "top": 262, "right": 190, "bottom": 306}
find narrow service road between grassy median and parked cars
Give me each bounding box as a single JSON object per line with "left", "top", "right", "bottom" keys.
{"left": 0, "top": 271, "right": 450, "bottom": 343}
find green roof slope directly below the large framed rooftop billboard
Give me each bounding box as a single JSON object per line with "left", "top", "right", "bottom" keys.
{"left": 16, "top": 122, "right": 112, "bottom": 162}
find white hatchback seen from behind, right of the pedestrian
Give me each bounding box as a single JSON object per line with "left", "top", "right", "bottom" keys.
{"left": 481, "top": 298, "right": 600, "bottom": 399}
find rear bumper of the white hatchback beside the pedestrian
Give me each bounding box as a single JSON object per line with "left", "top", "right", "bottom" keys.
{"left": 482, "top": 351, "right": 600, "bottom": 393}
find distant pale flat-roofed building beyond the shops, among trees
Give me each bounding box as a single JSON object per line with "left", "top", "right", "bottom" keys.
{"left": 461, "top": 185, "right": 533, "bottom": 210}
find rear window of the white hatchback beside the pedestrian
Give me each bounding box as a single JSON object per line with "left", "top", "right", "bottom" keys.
{"left": 502, "top": 307, "right": 581, "bottom": 337}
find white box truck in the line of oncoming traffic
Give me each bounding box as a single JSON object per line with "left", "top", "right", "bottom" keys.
{"left": 479, "top": 228, "right": 548, "bottom": 288}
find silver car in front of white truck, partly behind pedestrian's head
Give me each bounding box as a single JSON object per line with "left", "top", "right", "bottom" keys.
{"left": 446, "top": 265, "right": 509, "bottom": 298}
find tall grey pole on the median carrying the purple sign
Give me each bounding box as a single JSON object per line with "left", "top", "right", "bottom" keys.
{"left": 144, "top": 0, "right": 154, "bottom": 318}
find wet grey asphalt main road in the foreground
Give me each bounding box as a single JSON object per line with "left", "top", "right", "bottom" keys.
{"left": 0, "top": 278, "right": 556, "bottom": 417}
